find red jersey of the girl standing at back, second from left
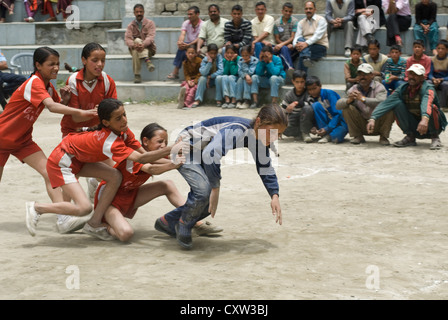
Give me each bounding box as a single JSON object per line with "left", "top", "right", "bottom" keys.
{"left": 61, "top": 70, "right": 117, "bottom": 137}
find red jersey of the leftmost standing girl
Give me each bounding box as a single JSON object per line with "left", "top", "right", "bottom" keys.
{"left": 0, "top": 72, "right": 61, "bottom": 150}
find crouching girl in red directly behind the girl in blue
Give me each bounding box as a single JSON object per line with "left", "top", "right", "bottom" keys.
{"left": 95, "top": 123, "right": 185, "bottom": 241}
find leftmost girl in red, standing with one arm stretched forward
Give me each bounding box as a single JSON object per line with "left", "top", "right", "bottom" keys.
{"left": 0, "top": 47, "right": 97, "bottom": 201}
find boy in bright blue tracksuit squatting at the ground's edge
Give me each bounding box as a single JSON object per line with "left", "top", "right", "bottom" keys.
{"left": 306, "top": 76, "right": 348, "bottom": 143}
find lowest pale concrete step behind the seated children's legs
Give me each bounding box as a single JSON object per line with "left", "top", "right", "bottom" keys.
{"left": 116, "top": 81, "right": 345, "bottom": 104}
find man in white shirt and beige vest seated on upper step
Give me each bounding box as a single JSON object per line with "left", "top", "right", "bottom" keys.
{"left": 292, "top": 1, "right": 328, "bottom": 72}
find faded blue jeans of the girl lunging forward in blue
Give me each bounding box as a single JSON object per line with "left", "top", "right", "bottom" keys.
{"left": 165, "top": 157, "right": 212, "bottom": 232}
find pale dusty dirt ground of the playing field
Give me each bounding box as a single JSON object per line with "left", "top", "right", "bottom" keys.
{"left": 0, "top": 103, "right": 448, "bottom": 300}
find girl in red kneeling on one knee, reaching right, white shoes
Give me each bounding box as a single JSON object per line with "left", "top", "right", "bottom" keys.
{"left": 26, "top": 99, "right": 182, "bottom": 240}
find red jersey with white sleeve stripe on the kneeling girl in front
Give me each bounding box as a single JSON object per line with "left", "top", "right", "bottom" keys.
{"left": 59, "top": 128, "right": 141, "bottom": 163}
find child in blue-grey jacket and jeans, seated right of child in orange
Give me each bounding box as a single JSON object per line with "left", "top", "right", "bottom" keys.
{"left": 191, "top": 43, "right": 223, "bottom": 108}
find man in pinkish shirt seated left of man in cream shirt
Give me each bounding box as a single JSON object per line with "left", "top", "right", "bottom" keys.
{"left": 167, "top": 6, "right": 203, "bottom": 80}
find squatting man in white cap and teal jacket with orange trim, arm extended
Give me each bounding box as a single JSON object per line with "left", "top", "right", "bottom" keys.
{"left": 367, "top": 64, "right": 447, "bottom": 150}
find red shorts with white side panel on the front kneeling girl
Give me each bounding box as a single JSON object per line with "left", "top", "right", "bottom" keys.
{"left": 47, "top": 147, "right": 84, "bottom": 188}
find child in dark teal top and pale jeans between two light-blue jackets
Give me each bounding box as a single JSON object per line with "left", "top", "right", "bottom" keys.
{"left": 216, "top": 44, "right": 240, "bottom": 109}
